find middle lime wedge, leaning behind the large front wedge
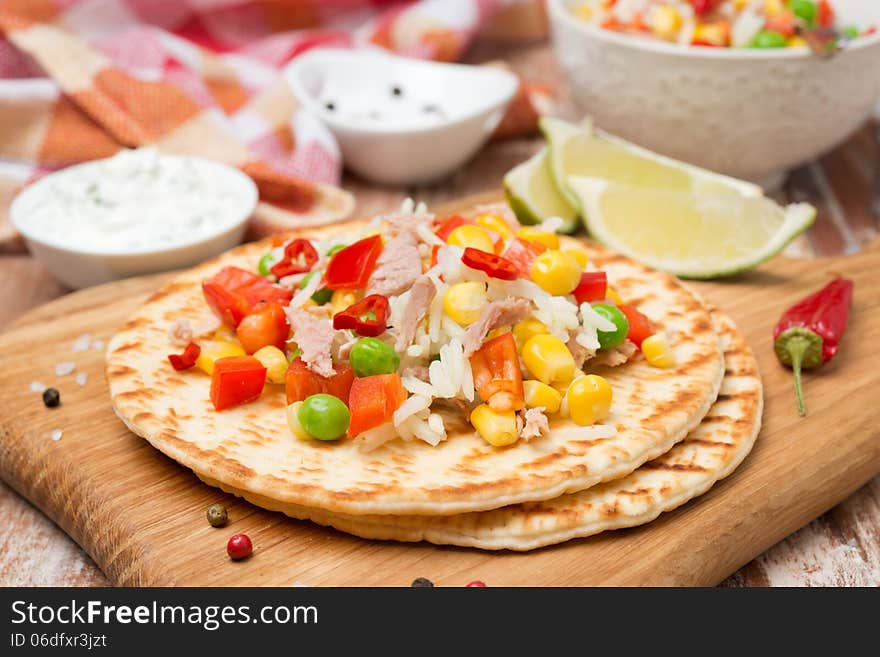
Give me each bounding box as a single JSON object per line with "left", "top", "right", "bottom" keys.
{"left": 540, "top": 117, "right": 763, "bottom": 212}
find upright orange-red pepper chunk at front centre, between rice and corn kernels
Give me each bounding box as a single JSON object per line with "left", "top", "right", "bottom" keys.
{"left": 470, "top": 332, "right": 525, "bottom": 411}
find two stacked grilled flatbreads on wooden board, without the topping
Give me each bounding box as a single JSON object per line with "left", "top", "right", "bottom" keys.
{"left": 107, "top": 219, "right": 762, "bottom": 550}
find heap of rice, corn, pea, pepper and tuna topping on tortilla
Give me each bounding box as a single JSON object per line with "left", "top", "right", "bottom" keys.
{"left": 169, "top": 201, "right": 675, "bottom": 449}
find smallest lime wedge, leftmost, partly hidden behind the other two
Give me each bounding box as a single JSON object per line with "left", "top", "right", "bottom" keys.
{"left": 504, "top": 148, "right": 579, "bottom": 233}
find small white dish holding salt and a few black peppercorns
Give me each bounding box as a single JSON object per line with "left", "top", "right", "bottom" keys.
{"left": 284, "top": 48, "right": 519, "bottom": 185}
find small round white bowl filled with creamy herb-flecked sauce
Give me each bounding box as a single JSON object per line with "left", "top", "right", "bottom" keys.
{"left": 10, "top": 149, "right": 258, "bottom": 288}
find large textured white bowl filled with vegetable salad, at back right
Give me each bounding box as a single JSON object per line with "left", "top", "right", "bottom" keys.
{"left": 548, "top": 0, "right": 880, "bottom": 188}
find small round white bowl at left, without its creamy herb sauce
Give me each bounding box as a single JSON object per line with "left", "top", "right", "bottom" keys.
{"left": 10, "top": 155, "right": 258, "bottom": 288}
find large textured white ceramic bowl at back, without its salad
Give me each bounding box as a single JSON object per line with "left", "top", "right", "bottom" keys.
{"left": 548, "top": 0, "right": 880, "bottom": 187}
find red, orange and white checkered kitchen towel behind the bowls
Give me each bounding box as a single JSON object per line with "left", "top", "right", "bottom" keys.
{"left": 0, "top": 0, "right": 548, "bottom": 242}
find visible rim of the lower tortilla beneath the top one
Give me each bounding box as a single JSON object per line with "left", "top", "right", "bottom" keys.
{"left": 242, "top": 312, "right": 763, "bottom": 551}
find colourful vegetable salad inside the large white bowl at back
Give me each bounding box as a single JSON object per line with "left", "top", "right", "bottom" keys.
{"left": 572, "top": 0, "right": 877, "bottom": 48}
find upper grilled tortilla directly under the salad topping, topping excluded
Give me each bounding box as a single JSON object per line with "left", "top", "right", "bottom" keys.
{"left": 106, "top": 223, "right": 724, "bottom": 515}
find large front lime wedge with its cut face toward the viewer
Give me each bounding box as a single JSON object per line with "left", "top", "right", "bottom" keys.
{"left": 566, "top": 176, "right": 816, "bottom": 278}
